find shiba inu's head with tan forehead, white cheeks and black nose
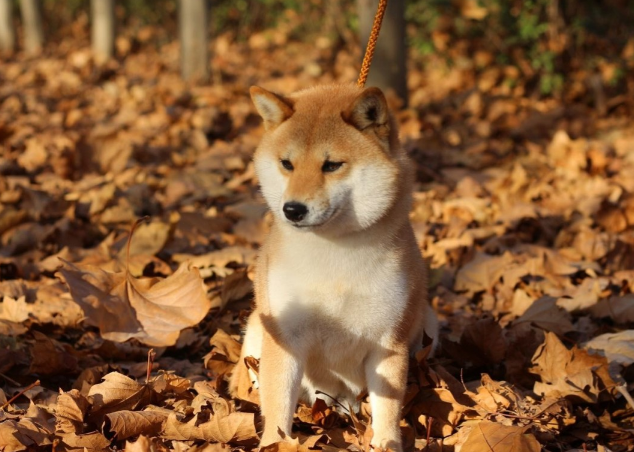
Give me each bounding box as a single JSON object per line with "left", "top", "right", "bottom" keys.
{"left": 251, "top": 85, "right": 401, "bottom": 233}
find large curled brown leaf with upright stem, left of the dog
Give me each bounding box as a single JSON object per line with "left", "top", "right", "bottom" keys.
{"left": 60, "top": 261, "right": 210, "bottom": 347}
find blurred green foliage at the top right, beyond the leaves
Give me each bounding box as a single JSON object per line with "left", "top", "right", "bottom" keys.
{"left": 407, "top": 0, "right": 634, "bottom": 95}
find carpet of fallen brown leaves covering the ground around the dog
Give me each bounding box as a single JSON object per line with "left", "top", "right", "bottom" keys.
{"left": 0, "top": 23, "right": 634, "bottom": 452}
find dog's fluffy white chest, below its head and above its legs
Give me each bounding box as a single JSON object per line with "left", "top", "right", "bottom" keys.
{"left": 268, "top": 234, "right": 407, "bottom": 339}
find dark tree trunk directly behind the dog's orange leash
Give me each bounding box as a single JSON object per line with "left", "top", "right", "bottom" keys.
{"left": 357, "top": 0, "right": 407, "bottom": 104}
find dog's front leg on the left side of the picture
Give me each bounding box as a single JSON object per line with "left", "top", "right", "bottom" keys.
{"left": 260, "top": 331, "right": 304, "bottom": 447}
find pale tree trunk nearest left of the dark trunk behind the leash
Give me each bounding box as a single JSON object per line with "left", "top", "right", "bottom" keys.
{"left": 178, "top": 0, "right": 209, "bottom": 83}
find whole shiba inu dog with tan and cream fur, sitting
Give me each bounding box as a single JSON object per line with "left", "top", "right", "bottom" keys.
{"left": 230, "top": 85, "right": 437, "bottom": 451}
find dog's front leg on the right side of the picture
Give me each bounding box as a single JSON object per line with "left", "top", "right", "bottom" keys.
{"left": 365, "top": 346, "right": 409, "bottom": 452}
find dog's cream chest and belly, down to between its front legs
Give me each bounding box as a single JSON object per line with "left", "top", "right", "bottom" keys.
{"left": 267, "top": 233, "right": 409, "bottom": 402}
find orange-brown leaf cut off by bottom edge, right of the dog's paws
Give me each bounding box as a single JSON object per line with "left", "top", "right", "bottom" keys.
{"left": 460, "top": 421, "right": 542, "bottom": 452}
